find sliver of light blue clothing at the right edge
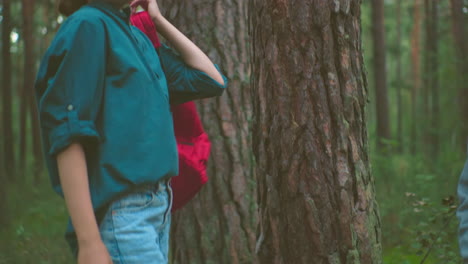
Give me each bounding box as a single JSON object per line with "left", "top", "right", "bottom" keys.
{"left": 457, "top": 160, "right": 468, "bottom": 263}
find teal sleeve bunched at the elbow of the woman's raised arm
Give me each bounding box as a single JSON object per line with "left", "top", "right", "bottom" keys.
{"left": 158, "top": 44, "right": 228, "bottom": 104}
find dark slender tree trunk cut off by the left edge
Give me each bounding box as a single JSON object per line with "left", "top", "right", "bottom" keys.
{"left": 0, "top": 0, "right": 15, "bottom": 225}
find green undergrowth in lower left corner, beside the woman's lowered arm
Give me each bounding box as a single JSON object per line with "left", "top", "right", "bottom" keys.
{"left": 0, "top": 180, "right": 73, "bottom": 264}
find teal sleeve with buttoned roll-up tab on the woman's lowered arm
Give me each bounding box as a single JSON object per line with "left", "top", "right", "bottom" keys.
{"left": 35, "top": 20, "right": 106, "bottom": 155}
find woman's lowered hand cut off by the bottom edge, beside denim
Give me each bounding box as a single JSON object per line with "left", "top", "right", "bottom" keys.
{"left": 78, "top": 241, "right": 112, "bottom": 264}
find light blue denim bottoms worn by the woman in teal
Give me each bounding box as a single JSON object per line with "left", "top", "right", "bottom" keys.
{"left": 99, "top": 180, "right": 172, "bottom": 264}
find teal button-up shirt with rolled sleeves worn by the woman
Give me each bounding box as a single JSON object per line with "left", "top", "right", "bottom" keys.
{"left": 35, "top": 1, "right": 227, "bottom": 252}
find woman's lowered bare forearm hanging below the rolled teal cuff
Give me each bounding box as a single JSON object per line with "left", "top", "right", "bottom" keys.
{"left": 57, "top": 143, "right": 101, "bottom": 245}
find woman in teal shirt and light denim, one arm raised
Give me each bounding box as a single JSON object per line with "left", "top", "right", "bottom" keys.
{"left": 35, "top": 0, "right": 227, "bottom": 264}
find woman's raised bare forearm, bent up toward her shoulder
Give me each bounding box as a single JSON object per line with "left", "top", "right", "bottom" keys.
{"left": 153, "top": 15, "right": 224, "bottom": 85}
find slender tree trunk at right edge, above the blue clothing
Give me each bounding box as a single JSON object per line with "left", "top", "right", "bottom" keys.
{"left": 450, "top": 0, "right": 468, "bottom": 147}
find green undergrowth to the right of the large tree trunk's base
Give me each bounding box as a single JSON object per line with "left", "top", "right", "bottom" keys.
{"left": 371, "top": 147, "right": 464, "bottom": 264}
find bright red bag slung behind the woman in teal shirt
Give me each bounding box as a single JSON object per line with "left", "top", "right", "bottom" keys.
{"left": 130, "top": 12, "right": 210, "bottom": 211}
